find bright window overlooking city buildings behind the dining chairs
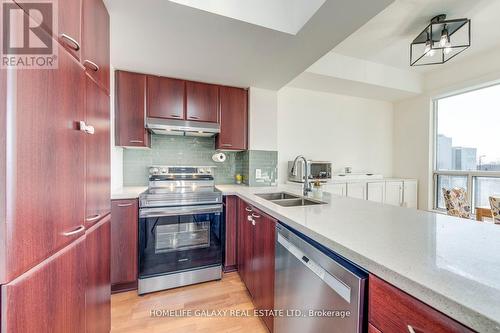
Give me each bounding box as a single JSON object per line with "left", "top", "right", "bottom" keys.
{"left": 434, "top": 84, "right": 500, "bottom": 209}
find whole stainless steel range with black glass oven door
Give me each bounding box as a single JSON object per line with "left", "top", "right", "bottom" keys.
{"left": 138, "top": 166, "right": 223, "bottom": 294}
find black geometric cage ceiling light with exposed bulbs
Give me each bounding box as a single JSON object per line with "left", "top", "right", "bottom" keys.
{"left": 410, "top": 14, "right": 470, "bottom": 66}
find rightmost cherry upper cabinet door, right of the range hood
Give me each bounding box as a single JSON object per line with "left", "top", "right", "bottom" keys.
{"left": 216, "top": 87, "right": 248, "bottom": 150}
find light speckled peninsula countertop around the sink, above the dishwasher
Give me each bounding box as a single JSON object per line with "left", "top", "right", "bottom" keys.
{"left": 217, "top": 185, "right": 500, "bottom": 332}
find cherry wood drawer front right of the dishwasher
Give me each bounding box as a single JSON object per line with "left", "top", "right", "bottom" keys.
{"left": 368, "top": 275, "right": 473, "bottom": 333}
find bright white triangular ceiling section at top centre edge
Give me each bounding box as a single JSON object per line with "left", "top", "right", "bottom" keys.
{"left": 166, "top": 0, "right": 325, "bottom": 35}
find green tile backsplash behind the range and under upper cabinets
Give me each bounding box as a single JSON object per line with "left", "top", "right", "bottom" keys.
{"left": 123, "top": 135, "right": 278, "bottom": 186}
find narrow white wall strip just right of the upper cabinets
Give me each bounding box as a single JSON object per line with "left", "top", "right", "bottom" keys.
{"left": 248, "top": 87, "right": 278, "bottom": 150}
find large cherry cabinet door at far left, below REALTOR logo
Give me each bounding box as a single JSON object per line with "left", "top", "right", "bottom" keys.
{"left": 0, "top": 36, "right": 85, "bottom": 283}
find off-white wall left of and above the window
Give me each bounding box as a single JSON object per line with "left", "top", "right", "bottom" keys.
{"left": 393, "top": 48, "right": 500, "bottom": 209}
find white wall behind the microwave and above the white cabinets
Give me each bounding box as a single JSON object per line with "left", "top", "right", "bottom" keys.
{"left": 276, "top": 87, "right": 393, "bottom": 182}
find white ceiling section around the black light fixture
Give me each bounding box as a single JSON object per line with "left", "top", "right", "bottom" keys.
{"left": 333, "top": 0, "right": 500, "bottom": 72}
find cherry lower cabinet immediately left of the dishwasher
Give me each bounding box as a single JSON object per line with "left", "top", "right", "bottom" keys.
{"left": 238, "top": 200, "right": 277, "bottom": 332}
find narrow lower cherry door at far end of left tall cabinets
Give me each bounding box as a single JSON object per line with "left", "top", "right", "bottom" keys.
{"left": 85, "top": 215, "right": 111, "bottom": 333}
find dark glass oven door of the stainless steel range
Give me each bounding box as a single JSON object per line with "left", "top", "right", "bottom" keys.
{"left": 139, "top": 205, "right": 222, "bottom": 278}
